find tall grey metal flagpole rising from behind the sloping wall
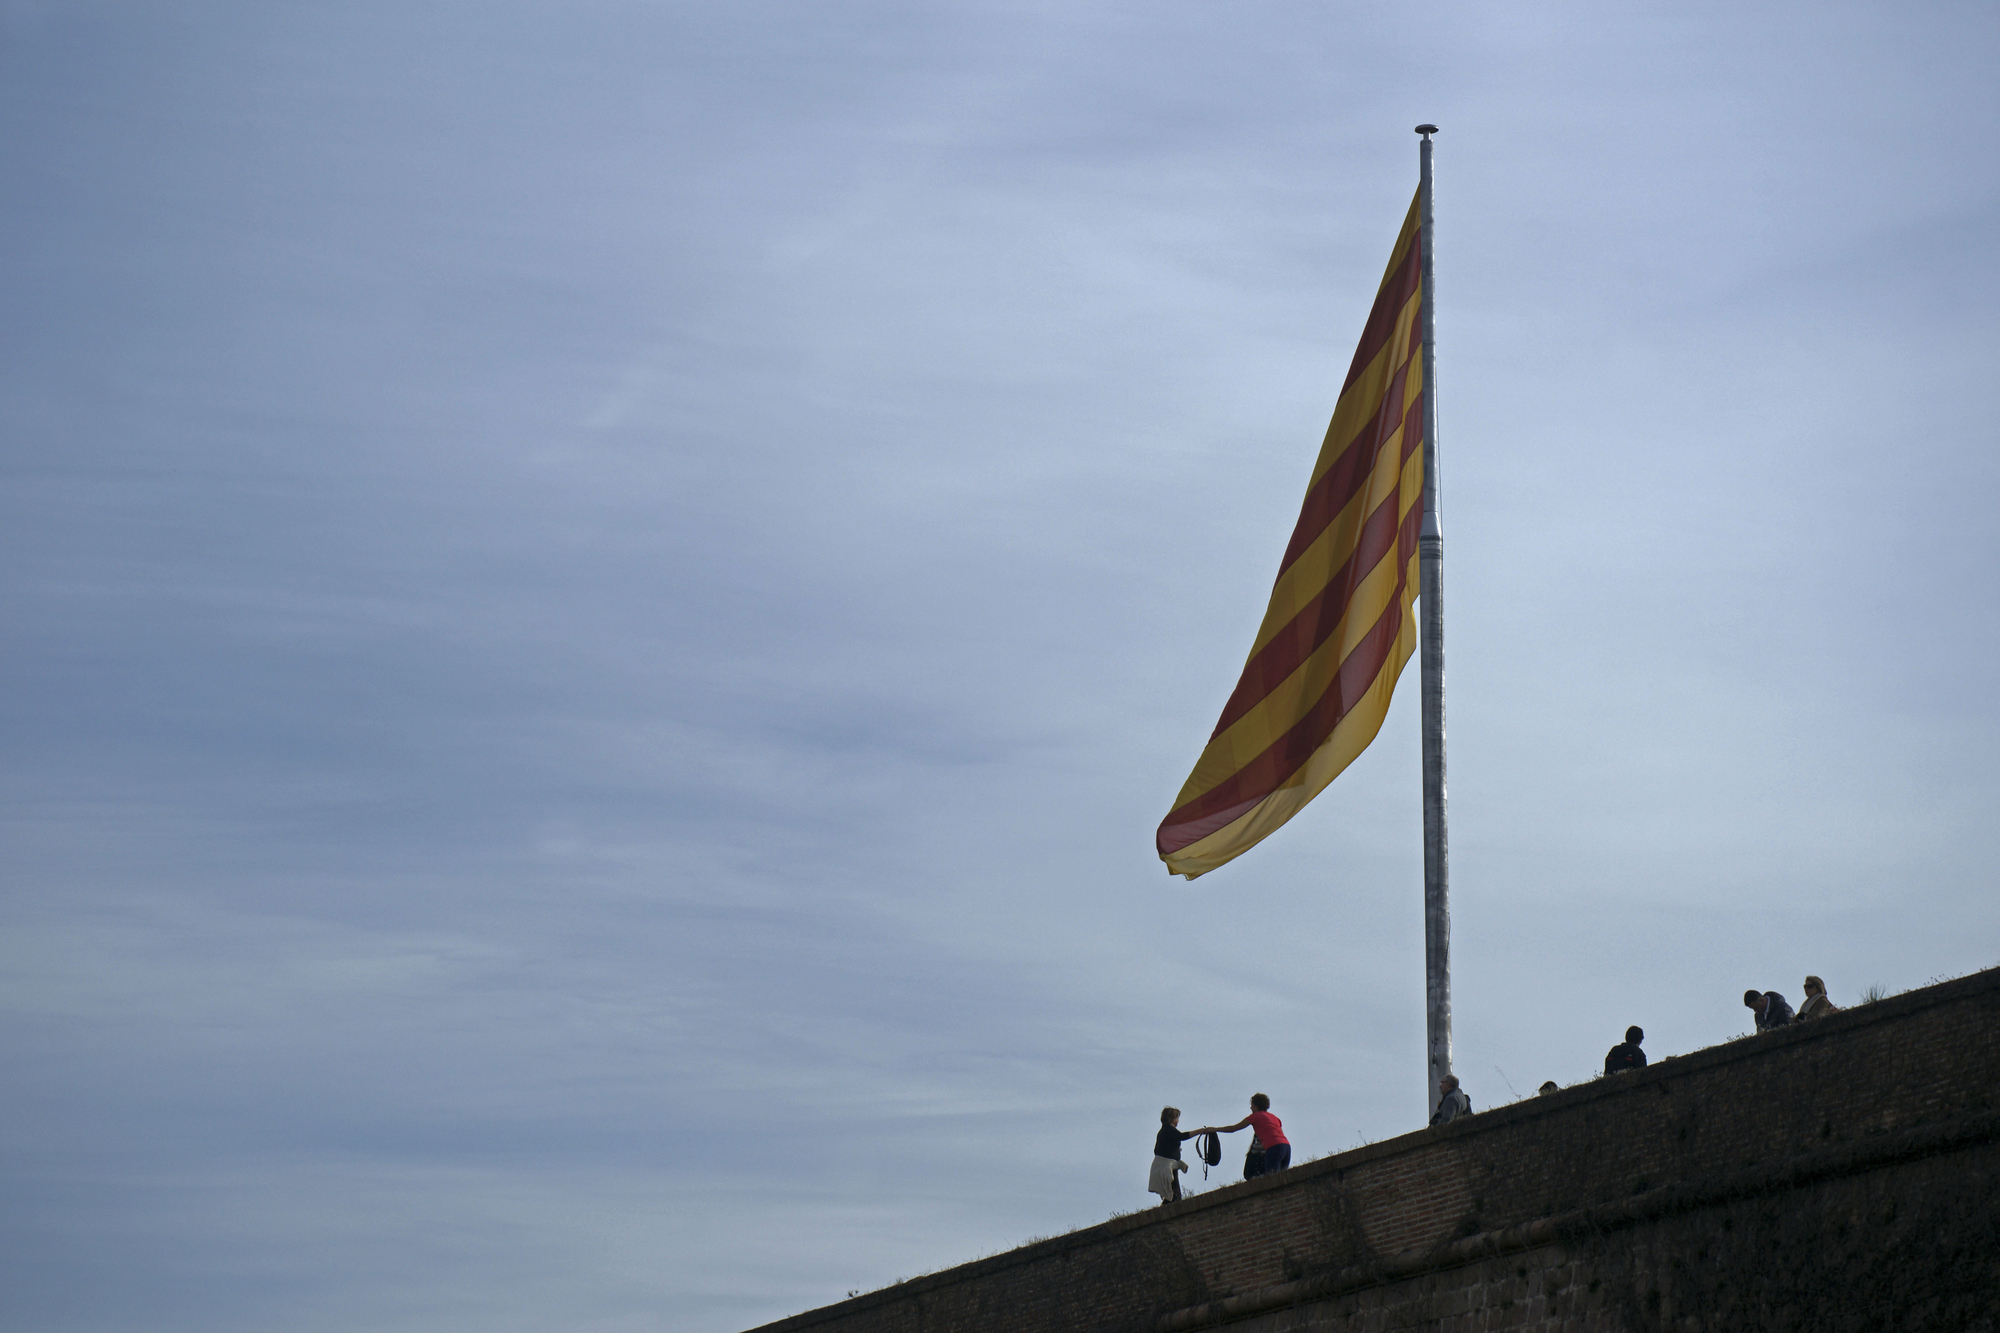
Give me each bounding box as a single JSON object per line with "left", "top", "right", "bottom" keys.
{"left": 1416, "top": 124, "right": 1452, "bottom": 1111}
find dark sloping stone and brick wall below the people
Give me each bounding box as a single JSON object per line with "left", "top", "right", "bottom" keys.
{"left": 760, "top": 969, "right": 2000, "bottom": 1333}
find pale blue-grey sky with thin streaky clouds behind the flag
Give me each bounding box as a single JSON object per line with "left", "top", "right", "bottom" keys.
{"left": 0, "top": 0, "right": 2000, "bottom": 1333}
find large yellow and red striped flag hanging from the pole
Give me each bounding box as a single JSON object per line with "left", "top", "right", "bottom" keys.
{"left": 1158, "top": 187, "right": 1428, "bottom": 879}
